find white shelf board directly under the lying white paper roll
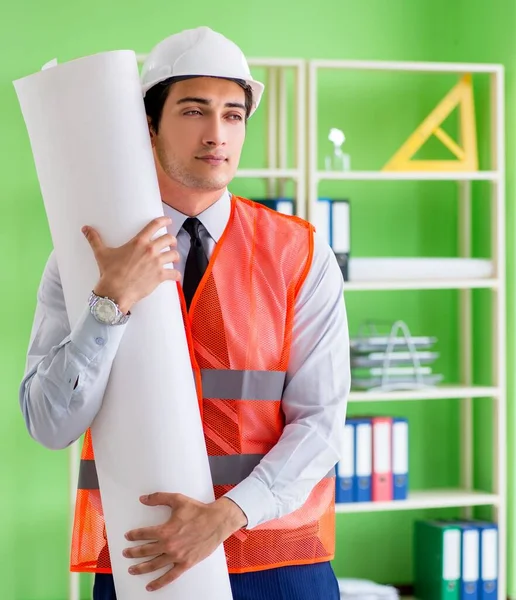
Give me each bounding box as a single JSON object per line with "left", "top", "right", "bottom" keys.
{"left": 344, "top": 278, "right": 498, "bottom": 293}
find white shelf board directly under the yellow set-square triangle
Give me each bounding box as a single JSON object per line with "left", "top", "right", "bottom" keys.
{"left": 316, "top": 171, "right": 500, "bottom": 181}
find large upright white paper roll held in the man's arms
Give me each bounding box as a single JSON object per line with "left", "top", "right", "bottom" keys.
{"left": 15, "top": 51, "right": 231, "bottom": 600}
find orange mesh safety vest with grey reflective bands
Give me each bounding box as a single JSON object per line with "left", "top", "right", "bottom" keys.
{"left": 71, "top": 196, "right": 335, "bottom": 573}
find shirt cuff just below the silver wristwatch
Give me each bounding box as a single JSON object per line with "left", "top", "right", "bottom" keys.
{"left": 70, "top": 307, "right": 127, "bottom": 363}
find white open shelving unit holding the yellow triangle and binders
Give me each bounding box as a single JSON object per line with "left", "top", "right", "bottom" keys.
{"left": 307, "top": 60, "right": 507, "bottom": 600}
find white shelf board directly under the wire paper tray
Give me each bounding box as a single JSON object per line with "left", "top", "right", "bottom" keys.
{"left": 348, "top": 385, "right": 500, "bottom": 402}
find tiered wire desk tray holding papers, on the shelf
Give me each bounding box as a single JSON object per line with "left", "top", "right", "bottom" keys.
{"left": 350, "top": 321, "right": 443, "bottom": 390}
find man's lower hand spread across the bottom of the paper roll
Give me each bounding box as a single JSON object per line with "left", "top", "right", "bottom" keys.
{"left": 124, "top": 493, "right": 247, "bottom": 591}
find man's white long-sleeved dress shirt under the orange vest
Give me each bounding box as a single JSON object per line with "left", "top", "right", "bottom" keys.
{"left": 20, "top": 192, "right": 351, "bottom": 528}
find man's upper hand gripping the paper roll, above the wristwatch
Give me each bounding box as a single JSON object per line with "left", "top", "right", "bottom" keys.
{"left": 82, "top": 217, "right": 181, "bottom": 314}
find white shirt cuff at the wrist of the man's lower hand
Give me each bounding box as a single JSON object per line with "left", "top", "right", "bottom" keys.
{"left": 224, "top": 475, "right": 278, "bottom": 529}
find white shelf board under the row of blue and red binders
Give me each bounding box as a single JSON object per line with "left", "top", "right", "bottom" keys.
{"left": 335, "top": 489, "right": 499, "bottom": 513}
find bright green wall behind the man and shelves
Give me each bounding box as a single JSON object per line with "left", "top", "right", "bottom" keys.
{"left": 0, "top": 0, "right": 516, "bottom": 600}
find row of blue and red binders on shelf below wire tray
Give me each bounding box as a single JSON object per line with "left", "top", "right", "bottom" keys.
{"left": 335, "top": 417, "right": 409, "bottom": 503}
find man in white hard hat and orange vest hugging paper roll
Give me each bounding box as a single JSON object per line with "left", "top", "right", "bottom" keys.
{"left": 20, "top": 27, "right": 350, "bottom": 600}
